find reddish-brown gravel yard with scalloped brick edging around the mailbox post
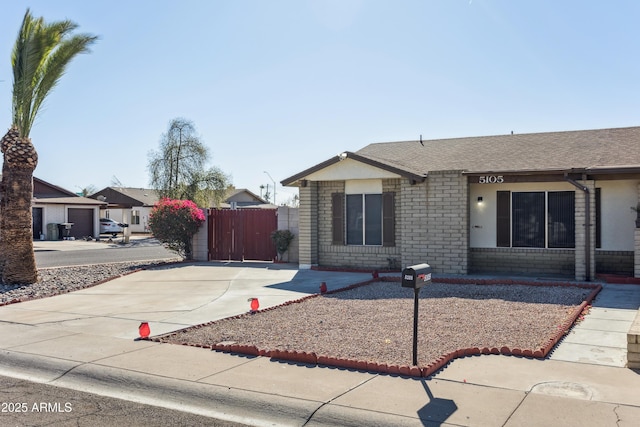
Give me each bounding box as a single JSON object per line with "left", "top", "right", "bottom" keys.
{"left": 160, "top": 282, "right": 592, "bottom": 365}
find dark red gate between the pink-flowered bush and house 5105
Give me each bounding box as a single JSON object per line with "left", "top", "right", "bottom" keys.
{"left": 209, "top": 209, "right": 278, "bottom": 261}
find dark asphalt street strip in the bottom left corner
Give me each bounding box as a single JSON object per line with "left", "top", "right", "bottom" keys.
{"left": 0, "top": 376, "right": 244, "bottom": 427}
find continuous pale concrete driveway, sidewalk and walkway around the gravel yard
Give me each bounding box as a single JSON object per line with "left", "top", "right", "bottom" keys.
{"left": 0, "top": 263, "right": 640, "bottom": 427}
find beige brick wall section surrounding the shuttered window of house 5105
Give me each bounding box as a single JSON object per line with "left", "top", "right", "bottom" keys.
{"left": 299, "top": 171, "right": 468, "bottom": 274}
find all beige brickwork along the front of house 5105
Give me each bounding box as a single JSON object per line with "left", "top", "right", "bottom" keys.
{"left": 299, "top": 171, "right": 616, "bottom": 280}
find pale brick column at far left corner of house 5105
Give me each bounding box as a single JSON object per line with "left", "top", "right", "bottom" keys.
{"left": 298, "top": 181, "right": 318, "bottom": 269}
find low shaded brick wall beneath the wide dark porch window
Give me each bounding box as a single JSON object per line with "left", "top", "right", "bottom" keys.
{"left": 469, "top": 248, "right": 575, "bottom": 277}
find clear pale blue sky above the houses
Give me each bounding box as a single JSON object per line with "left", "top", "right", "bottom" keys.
{"left": 0, "top": 0, "right": 640, "bottom": 206}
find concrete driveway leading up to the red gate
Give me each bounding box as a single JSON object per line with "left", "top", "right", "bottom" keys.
{"left": 0, "top": 262, "right": 371, "bottom": 338}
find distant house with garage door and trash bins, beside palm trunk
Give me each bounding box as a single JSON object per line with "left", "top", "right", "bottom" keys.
{"left": 32, "top": 177, "right": 105, "bottom": 240}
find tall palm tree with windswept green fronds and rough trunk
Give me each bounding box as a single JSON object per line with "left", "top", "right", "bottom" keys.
{"left": 0, "top": 9, "right": 97, "bottom": 284}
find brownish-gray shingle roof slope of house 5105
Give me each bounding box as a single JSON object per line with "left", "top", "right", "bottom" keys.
{"left": 356, "top": 127, "right": 640, "bottom": 173}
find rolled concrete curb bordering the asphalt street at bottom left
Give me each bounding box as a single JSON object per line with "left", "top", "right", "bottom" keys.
{"left": 0, "top": 350, "right": 320, "bottom": 426}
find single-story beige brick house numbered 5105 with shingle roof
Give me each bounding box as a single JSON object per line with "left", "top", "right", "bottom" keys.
{"left": 282, "top": 127, "right": 640, "bottom": 280}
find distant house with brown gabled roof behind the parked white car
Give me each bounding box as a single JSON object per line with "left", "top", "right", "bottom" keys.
{"left": 89, "top": 187, "right": 159, "bottom": 233}
